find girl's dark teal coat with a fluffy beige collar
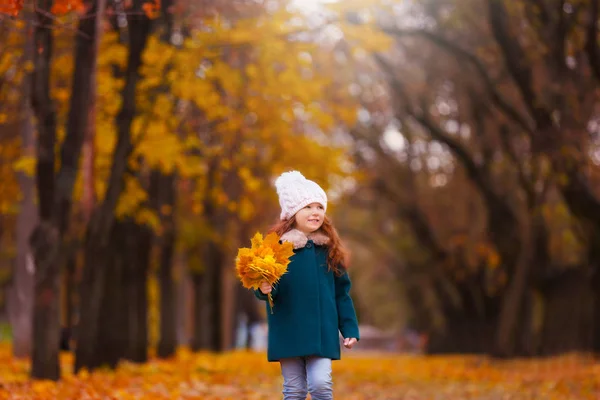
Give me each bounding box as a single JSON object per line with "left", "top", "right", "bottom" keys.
{"left": 255, "top": 230, "right": 360, "bottom": 361}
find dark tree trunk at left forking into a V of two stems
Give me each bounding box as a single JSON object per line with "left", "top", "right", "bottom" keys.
{"left": 31, "top": 2, "right": 101, "bottom": 379}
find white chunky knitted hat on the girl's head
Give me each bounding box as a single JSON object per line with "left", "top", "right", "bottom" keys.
{"left": 275, "top": 171, "right": 327, "bottom": 221}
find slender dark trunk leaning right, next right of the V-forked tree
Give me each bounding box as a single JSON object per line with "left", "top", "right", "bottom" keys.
{"left": 75, "top": 0, "right": 151, "bottom": 372}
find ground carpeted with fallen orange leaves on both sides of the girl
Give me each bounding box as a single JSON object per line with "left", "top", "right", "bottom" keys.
{"left": 0, "top": 345, "right": 600, "bottom": 400}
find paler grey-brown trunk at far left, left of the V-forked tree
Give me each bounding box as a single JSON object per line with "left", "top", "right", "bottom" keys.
{"left": 7, "top": 28, "right": 38, "bottom": 358}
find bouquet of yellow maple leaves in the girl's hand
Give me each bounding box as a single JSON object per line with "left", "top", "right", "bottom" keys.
{"left": 235, "top": 233, "right": 294, "bottom": 313}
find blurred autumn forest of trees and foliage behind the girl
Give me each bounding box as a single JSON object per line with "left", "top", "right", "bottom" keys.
{"left": 0, "top": 0, "right": 600, "bottom": 379}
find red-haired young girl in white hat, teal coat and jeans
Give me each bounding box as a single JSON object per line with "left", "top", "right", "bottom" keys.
{"left": 255, "top": 171, "right": 359, "bottom": 400}
